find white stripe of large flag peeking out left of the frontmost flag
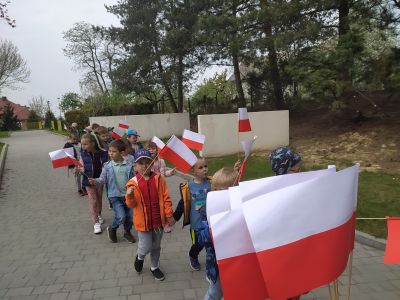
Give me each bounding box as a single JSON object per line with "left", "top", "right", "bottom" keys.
{"left": 211, "top": 209, "right": 255, "bottom": 260}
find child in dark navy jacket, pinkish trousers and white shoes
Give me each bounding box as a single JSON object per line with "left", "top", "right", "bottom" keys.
{"left": 79, "top": 133, "right": 108, "bottom": 234}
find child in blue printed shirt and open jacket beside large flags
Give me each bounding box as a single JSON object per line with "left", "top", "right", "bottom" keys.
{"left": 174, "top": 158, "right": 211, "bottom": 271}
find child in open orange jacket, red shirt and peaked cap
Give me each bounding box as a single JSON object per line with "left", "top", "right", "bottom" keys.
{"left": 125, "top": 149, "right": 174, "bottom": 281}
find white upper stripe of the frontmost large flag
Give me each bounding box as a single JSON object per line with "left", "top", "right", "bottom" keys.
{"left": 242, "top": 166, "right": 358, "bottom": 251}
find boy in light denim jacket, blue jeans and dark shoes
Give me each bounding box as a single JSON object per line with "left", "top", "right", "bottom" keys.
{"left": 89, "top": 140, "right": 136, "bottom": 243}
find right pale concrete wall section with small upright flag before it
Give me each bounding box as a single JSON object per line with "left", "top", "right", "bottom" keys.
{"left": 197, "top": 110, "right": 289, "bottom": 156}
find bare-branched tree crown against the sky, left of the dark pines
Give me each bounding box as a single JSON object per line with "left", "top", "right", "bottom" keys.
{"left": 63, "top": 22, "right": 121, "bottom": 93}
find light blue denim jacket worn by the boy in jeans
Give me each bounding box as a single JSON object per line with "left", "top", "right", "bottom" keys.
{"left": 96, "top": 160, "right": 135, "bottom": 198}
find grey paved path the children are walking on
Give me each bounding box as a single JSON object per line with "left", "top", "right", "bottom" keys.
{"left": 0, "top": 131, "right": 400, "bottom": 300}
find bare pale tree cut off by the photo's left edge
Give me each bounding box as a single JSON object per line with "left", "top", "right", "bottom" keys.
{"left": 0, "top": 40, "right": 31, "bottom": 91}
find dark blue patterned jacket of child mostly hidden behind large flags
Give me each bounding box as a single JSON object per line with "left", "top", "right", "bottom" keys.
{"left": 196, "top": 220, "right": 218, "bottom": 283}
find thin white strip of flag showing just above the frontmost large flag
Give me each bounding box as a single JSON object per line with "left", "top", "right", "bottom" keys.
{"left": 239, "top": 167, "right": 336, "bottom": 202}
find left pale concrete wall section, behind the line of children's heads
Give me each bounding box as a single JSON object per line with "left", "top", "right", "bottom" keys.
{"left": 89, "top": 113, "right": 190, "bottom": 141}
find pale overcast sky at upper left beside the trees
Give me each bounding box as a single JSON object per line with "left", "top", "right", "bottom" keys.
{"left": 0, "top": 0, "right": 119, "bottom": 113}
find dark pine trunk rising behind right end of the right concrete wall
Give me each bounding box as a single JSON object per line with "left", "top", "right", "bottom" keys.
{"left": 263, "top": 17, "right": 285, "bottom": 109}
